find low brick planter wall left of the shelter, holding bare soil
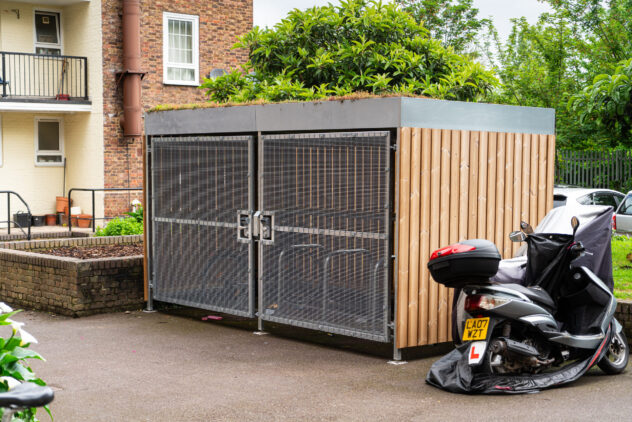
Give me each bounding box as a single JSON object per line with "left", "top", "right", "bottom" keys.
{"left": 0, "top": 236, "right": 144, "bottom": 316}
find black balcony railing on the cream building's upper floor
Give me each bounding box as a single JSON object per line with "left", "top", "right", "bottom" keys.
{"left": 0, "top": 51, "right": 88, "bottom": 102}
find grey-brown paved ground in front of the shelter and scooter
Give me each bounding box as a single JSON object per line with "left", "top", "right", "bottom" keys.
{"left": 16, "top": 312, "right": 632, "bottom": 422}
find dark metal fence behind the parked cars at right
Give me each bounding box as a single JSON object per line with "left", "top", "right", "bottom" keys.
{"left": 555, "top": 150, "right": 632, "bottom": 191}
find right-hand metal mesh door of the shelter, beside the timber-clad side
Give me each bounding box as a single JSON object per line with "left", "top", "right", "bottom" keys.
{"left": 259, "top": 132, "right": 390, "bottom": 341}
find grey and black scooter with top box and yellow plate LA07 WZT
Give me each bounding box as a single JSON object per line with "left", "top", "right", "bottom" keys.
{"left": 427, "top": 217, "right": 629, "bottom": 393}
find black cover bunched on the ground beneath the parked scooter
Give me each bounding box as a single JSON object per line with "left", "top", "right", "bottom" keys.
{"left": 426, "top": 329, "right": 611, "bottom": 394}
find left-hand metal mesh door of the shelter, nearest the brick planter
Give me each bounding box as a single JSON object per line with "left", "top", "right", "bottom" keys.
{"left": 151, "top": 136, "right": 254, "bottom": 316}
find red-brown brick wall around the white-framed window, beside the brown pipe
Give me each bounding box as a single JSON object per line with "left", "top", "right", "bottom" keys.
{"left": 102, "top": 0, "right": 252, "bottom": 216}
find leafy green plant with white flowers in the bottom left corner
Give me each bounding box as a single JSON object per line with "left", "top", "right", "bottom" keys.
{"left": 0, "top": 302, "right": 52, "bottom": 422}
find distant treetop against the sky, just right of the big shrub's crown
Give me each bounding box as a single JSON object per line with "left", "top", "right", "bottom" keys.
{"left": 395, "top": 0, "right": 492, "bottom": 53}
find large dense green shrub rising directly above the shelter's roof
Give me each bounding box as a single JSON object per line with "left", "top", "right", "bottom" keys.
{"left": 201, "top": 0, "right": 497, "bottom": 103}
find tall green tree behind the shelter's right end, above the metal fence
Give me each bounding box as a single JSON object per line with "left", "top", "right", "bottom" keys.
{"left": 492, "top": 0, "right": 632, "bottom": 149}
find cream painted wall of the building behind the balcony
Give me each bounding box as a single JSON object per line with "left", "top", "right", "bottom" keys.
{"left": 0, "top": 0, "right": 104, "bottom": 224}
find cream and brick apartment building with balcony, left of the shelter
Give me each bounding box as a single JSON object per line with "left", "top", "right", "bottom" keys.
{"left": 0, "top": 0, "right": 252, "bottom": 226}
